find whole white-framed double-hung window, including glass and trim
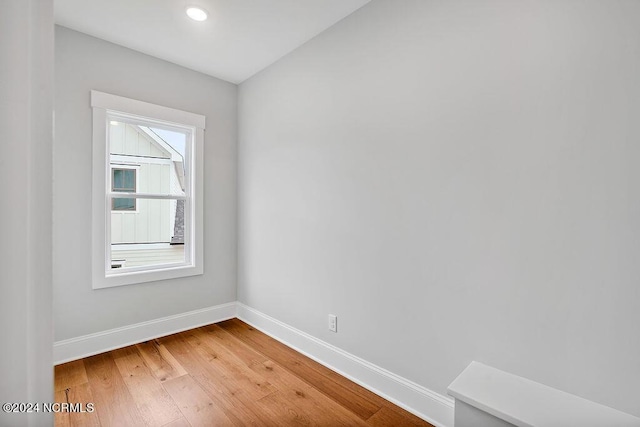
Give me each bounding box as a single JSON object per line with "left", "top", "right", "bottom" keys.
{"left": 91, "top": 91, "right": 205, "bottom": 289}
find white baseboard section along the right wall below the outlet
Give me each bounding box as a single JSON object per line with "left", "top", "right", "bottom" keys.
{"left": 237, "top": 302, "right": 454, "bottom": 427}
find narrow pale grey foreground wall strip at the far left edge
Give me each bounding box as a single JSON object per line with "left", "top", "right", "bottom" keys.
{"left": 0, "top": 0, "right": 53, "bottom": 426}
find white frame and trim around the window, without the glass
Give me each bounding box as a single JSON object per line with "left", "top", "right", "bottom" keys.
{"left": 91, "top": 90, "right": 205, "bottom": 289}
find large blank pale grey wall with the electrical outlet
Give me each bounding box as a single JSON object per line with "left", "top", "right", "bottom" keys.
{"left": 238, "top": 0, "right": 640, "bottom": 415}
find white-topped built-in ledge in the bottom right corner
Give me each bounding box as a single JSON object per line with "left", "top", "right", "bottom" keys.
{"left": 448, "top": 362, "right": 640, "bottom": 427}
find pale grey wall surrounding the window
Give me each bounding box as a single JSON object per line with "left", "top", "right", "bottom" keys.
{"left": 53, "top": 27, "right": 237, "bottom": 341}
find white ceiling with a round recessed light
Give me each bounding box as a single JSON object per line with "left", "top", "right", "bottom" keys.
{"left": 55, "top": 0, "right": 370, "bottom": 83}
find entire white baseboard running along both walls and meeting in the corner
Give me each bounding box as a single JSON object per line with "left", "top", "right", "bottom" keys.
{"left": 53, "top": 302, "right": 454, "bottom": 427}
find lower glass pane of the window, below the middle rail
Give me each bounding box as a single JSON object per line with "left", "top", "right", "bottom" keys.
{"left": 111, "top": 198, "right": 185, "bottom": 269}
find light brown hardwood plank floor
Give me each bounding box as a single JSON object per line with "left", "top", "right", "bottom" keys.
{"left": 55, "top": 319, "right": 433, "bottom": 427}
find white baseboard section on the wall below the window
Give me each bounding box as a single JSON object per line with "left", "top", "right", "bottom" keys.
{"left": 53, "top": 301, "right": 236, "bottom": 365}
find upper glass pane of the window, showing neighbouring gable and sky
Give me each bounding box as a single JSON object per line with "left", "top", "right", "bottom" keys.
{"left": 109, "top": 120, "right": 191, "bottom": 196}
